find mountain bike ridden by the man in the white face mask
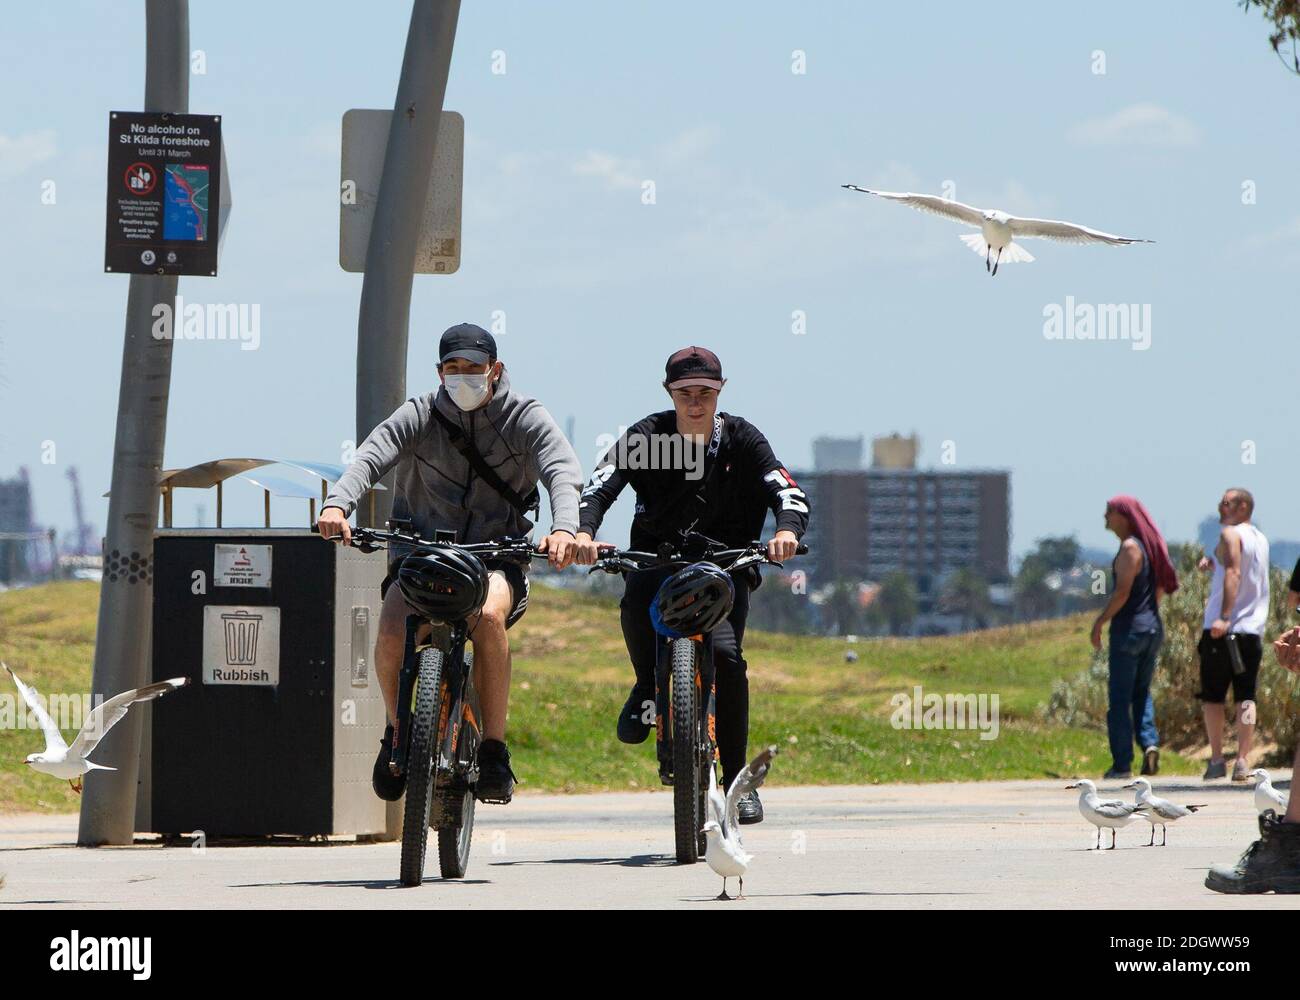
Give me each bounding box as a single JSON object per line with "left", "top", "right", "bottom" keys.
{"left": 340, "top": 521, "right": 546, "bottom": 886}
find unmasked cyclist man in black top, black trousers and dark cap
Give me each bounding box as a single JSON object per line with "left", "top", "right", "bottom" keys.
{"left": 575, "top": 347, "right": 809, "bottom": 823}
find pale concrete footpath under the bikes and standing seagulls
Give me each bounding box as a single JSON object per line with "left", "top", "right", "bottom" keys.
{"left": 0, "top": 772, "right": 1300, "bottom": 910}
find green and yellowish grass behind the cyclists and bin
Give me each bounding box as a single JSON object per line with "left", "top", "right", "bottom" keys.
{"left": 0, "top": 583, "right": 1197, "bottom": 811}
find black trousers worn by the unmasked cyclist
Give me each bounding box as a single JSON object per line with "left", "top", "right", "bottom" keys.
{"left": 619, "top": 570, "right": 749, "bottom": 789}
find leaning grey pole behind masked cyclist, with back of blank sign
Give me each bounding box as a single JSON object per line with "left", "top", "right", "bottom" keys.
{"left": 356, "top": 0, "right": 460, "bottom": 525}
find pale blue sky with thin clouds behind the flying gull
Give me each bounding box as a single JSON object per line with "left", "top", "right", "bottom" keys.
{"left": 0, "top": 0, "right": 1300, "bottom": 554}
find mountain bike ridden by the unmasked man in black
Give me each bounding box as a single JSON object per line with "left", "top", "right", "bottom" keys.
{"left": 589, "top": 532, "right": 807, "bottom": 865}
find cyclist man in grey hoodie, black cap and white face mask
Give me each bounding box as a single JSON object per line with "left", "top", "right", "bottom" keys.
{"left": 319, "top": 322, "right": 582, "bottom": 802}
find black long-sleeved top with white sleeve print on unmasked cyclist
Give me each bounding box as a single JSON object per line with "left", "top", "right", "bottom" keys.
{"left": 579, "top": 410, "right": 809, "bottom": 551}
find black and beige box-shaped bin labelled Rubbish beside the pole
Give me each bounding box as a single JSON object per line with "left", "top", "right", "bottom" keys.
{"left": 135, "top": 528, "right": 390, "bottom": 837}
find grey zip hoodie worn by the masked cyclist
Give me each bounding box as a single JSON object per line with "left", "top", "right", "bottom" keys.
{"left": 321, "top": 371, "right": 582, "bottom": 555}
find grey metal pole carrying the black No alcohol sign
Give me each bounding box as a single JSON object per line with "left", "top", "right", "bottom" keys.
{"left": 77, "top": 0, "right": 190, "bottom": 847}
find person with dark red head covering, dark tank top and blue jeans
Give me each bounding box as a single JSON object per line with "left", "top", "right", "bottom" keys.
{"left": 1092, "top": 494, "right": 1178, "bottom": 778}
